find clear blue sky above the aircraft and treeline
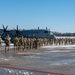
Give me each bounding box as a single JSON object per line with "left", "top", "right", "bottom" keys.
{"left": 0, "top": 0, "right": 75, "bottom": 33}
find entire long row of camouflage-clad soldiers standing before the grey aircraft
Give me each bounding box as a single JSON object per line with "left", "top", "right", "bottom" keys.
{"left": 0, "top": 35, "right": 75, "bottom": 52}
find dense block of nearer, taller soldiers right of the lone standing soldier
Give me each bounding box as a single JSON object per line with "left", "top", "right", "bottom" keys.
{"left": 13, "top": 36, "right": 38, "bottom": 50}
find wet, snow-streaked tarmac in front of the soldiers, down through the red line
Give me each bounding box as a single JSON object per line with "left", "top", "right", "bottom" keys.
{"left": 0, "top": 45, "right": 75, "bottom": 75}
